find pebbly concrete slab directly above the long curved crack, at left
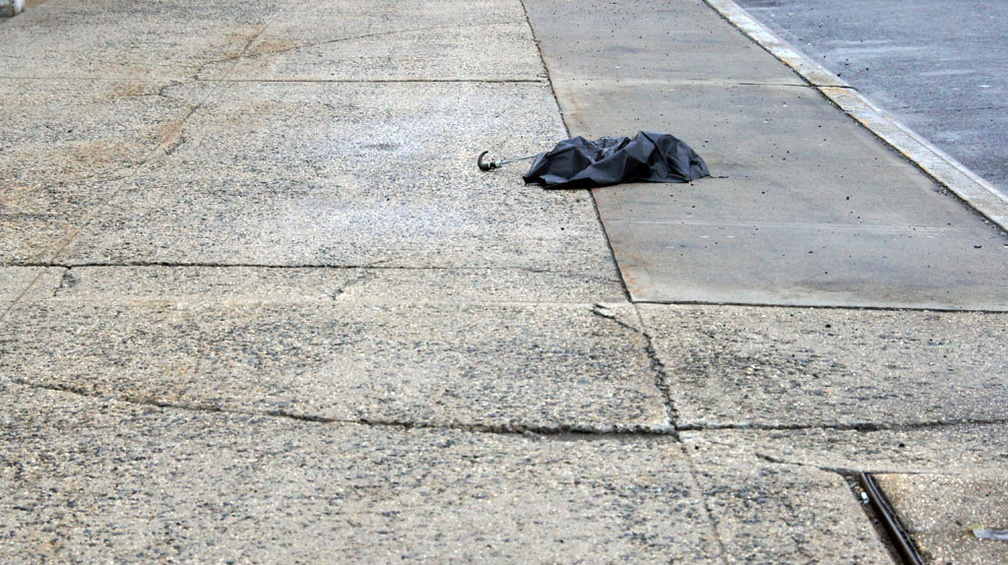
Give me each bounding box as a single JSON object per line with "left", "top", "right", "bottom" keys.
{"left": 0, "top": 299, "right": 668, "bottom": 431}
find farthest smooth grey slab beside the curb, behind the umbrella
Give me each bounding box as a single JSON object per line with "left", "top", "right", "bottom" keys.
{"left": 524, "top": 0, "right": 804, "bottom": 84}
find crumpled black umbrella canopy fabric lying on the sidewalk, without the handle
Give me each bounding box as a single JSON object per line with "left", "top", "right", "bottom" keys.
{"left": 522, "top": 132, "right": 711, "bottom": 188}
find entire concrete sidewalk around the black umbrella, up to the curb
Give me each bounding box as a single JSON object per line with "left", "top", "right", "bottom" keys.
{"left": 0, "top": 0, "right": 1008, "bottom": 563}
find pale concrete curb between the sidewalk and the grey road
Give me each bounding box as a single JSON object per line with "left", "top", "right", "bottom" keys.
{"left": 704, "top": 0, "right": 1008, "bottom": 232}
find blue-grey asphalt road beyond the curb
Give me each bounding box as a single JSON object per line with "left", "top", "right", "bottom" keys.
{"left": 736, "top": 0, "right": 1008, "bottom": 194}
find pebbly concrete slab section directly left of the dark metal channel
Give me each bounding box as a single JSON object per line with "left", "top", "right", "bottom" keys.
{"left": 683, "top": 431, "right": 892, "bottom": 564}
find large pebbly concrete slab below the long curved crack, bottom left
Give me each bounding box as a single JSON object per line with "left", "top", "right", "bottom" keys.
{"left": 0, "top": 384, "right": 722, "bottom": 563}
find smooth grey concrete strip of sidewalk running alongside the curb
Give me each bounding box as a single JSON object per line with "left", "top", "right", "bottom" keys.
{"left": 527, "top": 0, "right": 1008, "bottom": 310}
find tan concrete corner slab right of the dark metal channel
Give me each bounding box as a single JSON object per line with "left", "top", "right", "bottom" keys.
{"left": 873, "top": 471, "right": 1008, "bottom": 564}
